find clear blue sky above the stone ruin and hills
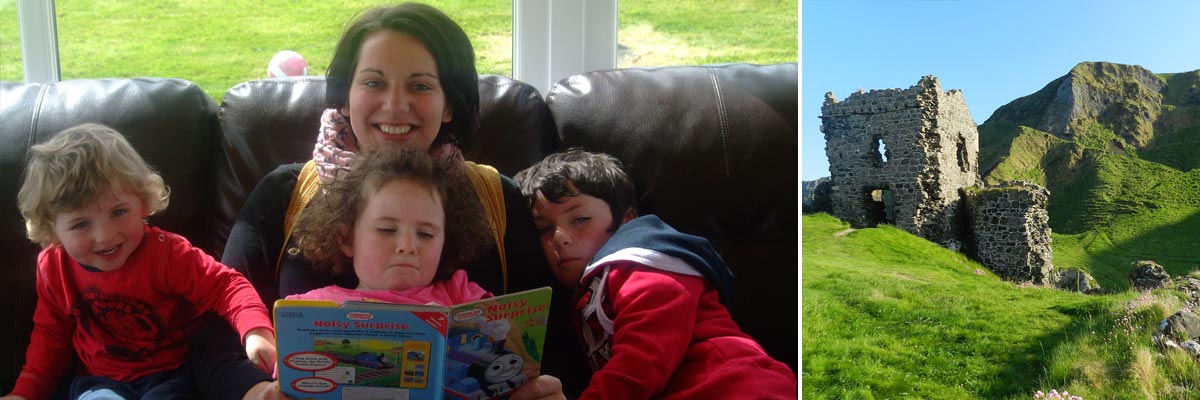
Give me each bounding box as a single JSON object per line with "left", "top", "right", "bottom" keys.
{"left": 800, "top": 0, "right": 1200, "bottom": 180}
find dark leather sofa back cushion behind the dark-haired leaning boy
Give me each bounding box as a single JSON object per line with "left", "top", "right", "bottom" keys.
{"left": 546, "top": 64, "right": 799, "bottom": 369}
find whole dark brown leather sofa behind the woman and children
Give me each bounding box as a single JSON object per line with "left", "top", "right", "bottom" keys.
{"left": 0, "top": 64, "right": 799, "bottom": 393}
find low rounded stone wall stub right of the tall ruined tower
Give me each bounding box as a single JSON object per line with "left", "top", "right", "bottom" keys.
{"left": 966, "top": 181, "right": 1054, "bottom": 283}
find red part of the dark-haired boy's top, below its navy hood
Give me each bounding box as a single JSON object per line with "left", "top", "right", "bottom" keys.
{"left": 575, "top": 262, "right": 798, "bottom": 400}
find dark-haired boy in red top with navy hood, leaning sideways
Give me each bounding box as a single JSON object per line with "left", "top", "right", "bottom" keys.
{"left": 515, "top": 149, "right": 797, "bottom": 399}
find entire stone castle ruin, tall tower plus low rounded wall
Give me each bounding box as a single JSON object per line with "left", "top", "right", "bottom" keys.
{"left": 821, "top": 76, "right": 1051, "bottom": 283}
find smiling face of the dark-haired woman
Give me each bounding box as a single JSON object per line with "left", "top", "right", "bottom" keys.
{"left": 341, "top": 30, "right": 451, "bottom": 151}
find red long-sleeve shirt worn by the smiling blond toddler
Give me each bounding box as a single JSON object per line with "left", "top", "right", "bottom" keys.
{"left": 11, "top": 226, "right": 274, "bottom": 399}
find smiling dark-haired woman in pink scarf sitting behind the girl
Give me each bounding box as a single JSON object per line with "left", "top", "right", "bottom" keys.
{"left": 193, "top": 2, "right": 586, "bottom": 399}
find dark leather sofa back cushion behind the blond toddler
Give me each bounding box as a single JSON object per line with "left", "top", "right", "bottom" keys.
{"left": 0, "top": 78, "right": 217, "bottom": 388}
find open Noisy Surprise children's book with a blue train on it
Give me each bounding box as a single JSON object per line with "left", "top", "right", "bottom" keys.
{"left": 275, "top": 287, "right": 551, "bottom": 400}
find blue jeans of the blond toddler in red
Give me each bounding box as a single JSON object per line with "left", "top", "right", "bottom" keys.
{"left": 71, "top": 368, "right": 200, "bottom": 400}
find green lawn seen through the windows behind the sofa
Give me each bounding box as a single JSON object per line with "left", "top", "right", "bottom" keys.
{"left": 0, "top": 0, "right": 798, "bottom": 101}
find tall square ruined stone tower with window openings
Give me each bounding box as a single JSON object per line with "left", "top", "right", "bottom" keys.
{"left": 821, "top": 77, "right": 980, "bottom": 249}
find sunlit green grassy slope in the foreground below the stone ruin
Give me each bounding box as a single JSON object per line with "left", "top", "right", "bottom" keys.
{"left": 802, "top": 214, "right": 1200, "bottom": 400}
